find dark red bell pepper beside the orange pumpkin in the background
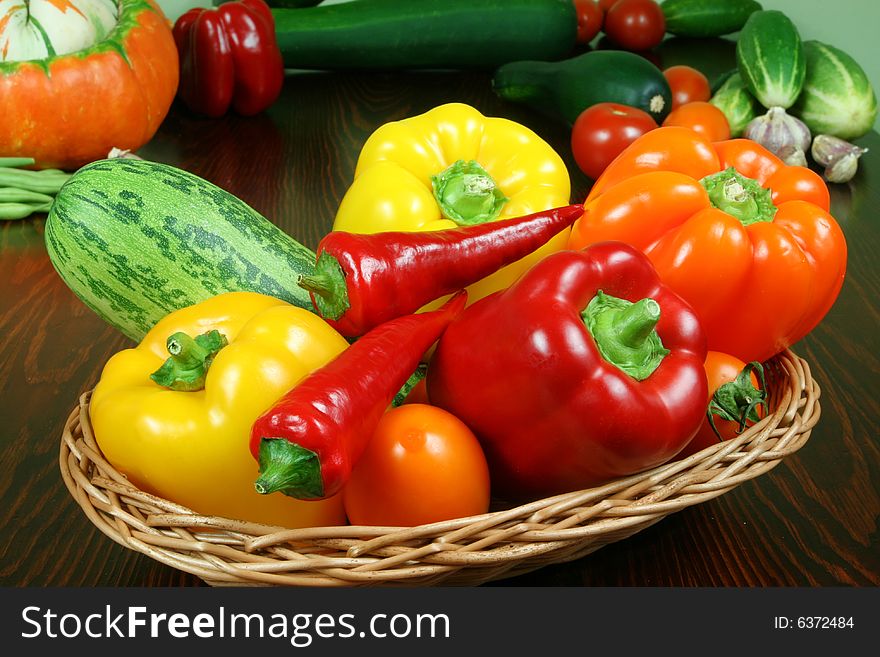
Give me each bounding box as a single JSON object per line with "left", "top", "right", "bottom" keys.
{"left": 173, "top": 0, "right": 284, "bottom": 118}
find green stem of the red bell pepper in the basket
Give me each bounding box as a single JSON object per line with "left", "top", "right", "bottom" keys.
{"left": 581, "top": 290, "right": 669, "bottom": 381}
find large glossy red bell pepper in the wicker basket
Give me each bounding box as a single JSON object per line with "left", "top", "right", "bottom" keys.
{"left": 427, "top": 242, "right": 707, "bottom": 499}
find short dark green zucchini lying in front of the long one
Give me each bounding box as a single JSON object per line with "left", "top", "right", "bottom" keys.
{"left": 492, "top": 50, "right": 672, "bottom": 124}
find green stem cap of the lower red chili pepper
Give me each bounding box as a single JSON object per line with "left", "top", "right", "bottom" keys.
{"left": 254, "top": 438, "right": 324, "bottom": 499}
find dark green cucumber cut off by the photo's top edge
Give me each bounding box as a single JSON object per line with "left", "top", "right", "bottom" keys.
{"left": 660, "top": 0, "right": 763, "bottom": 37}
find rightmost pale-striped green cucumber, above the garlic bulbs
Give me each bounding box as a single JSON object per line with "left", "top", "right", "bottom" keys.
{"left": 791, "top": 41, "right": 877, "bottom": 139}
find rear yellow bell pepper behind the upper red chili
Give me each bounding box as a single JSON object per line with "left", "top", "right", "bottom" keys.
{"left": 333, "top": 103, "right": 571, "bottom": 302}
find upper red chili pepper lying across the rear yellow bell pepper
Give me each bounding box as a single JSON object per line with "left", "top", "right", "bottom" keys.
{"left": 299, "top": 205, "right": 584, "bottom": 337}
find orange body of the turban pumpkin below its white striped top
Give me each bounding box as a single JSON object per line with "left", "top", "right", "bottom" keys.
{"left": 0, "top": 0, "right": 178, "bottom": 169}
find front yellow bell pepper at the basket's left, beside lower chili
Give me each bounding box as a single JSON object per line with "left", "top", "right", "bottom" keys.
{"left": 89, "top": 292, "right": 348, "bottom": 528}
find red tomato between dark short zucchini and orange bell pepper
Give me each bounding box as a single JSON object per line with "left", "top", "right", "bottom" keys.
{"left": 571, "top": 103, "right": 657, "bottom": 180}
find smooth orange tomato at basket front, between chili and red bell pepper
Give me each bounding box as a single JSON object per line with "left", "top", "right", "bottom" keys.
{"left": 343, "top": 404, "right": 489, "bottom": 527}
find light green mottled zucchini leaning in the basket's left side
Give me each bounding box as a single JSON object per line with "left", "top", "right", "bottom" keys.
{"left": 45, "top": 159, "right": 315, "bottom": 342}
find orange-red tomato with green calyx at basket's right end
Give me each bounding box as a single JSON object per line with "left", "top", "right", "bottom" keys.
{"left": 677, "top": 351, "right": 766, "bottom": 459}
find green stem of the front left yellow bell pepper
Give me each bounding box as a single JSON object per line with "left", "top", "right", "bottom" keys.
{"left": 150, "top": 330, "right": 229, "bottom": 392}
